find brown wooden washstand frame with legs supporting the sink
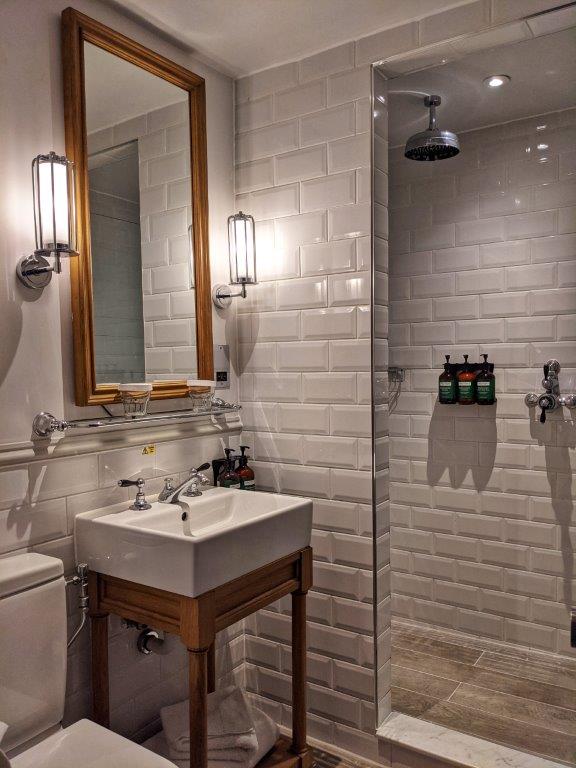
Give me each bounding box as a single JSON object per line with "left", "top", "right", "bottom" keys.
{"left": 88, "top": 547, "right": 313, "bottom": 768}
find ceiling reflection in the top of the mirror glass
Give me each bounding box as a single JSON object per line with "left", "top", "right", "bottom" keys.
{"left": 84, "top": 43, "right": 188, "bottom": 133}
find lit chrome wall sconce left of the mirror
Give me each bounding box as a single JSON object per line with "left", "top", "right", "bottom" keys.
{"left": 16, "top": 152, "right": 76, "bottom": 290}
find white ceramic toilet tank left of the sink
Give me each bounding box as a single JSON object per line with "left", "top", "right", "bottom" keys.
{"left": 0, "top": 553, "right": 67, "bottom": 751}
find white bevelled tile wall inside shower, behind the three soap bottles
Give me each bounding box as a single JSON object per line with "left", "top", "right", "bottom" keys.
{"left": 390, "top": 106, "right": 576, "bottom": 654}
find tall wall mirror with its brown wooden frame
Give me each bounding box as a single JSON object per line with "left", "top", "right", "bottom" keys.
{"left": 62, "top": 8, "right": 213, "bottom": 405}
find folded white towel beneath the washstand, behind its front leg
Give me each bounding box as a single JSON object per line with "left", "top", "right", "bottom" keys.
{"left": 160, "top": 686, "right": 258, "bottom": 755}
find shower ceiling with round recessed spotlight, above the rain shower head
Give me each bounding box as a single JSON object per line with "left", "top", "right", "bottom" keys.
{"left": 388, "top": 27, "right": 576, "bottom": 146}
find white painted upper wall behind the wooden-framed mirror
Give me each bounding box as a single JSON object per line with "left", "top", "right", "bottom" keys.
{"left": 0, "top": 0, "right": 234, "bottom": 444}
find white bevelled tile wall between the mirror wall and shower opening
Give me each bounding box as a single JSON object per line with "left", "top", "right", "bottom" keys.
{"left": 236, "top": 44, "right": 382, "bottom": 756}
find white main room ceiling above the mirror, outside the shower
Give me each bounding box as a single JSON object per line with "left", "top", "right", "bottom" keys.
{"left": 108, "top": 0, "right": 472, "bottom": 77}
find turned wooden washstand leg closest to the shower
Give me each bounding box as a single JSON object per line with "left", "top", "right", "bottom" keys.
{"left": 292, "top": 592, "right": 312, "bottom": 766}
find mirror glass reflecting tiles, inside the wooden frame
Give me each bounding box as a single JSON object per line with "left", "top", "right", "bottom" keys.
{"left": 84, "top": 42, "right": 197, "bottom": 384}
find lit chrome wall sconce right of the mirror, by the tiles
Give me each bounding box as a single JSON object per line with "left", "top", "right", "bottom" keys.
{"left": 212, "top": 211, "right": 258, "bottom": 309}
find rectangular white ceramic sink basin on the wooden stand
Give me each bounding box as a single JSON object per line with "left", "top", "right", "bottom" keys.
{"left": 75, "top": 488, "right": 312, "bottom": 597}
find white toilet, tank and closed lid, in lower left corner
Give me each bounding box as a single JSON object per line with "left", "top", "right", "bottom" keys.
{"left": 0, "top": 553, "right": 174, "bottom": 768}
